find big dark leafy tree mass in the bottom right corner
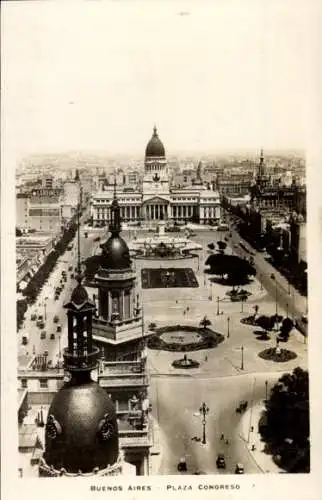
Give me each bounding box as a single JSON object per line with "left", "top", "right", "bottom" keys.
{"left": 259, "top": 367, "right": 310, "bottom": 472}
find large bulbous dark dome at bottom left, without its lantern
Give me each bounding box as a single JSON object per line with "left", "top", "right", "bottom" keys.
{"left": 44, "top": 375, "right": 119, "bottom": 473}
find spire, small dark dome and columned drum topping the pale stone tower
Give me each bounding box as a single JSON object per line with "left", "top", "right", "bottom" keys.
{"left": 89, "top": 178, "right": 149, "bottom": 361}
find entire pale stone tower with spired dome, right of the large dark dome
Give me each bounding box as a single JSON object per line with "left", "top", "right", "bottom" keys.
{"left": 87, "top": 183, "right": 152, "bottom": 475}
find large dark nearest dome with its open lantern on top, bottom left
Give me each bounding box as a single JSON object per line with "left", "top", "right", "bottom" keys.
{"left": 39, "top": 277, "right": 133, "bottom": 477}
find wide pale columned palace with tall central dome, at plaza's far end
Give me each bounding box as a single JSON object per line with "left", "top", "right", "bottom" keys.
{"left": 91, "top": 127, "right": 220, "bottom": 226}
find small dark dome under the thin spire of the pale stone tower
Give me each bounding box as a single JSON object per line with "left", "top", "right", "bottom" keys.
{"left": 101, "top": 234, "right": 131, "bottom": 269}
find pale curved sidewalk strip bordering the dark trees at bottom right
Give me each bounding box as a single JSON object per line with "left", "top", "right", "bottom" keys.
{"left": 240, "top": 401, "right": 284, "bottom": 473}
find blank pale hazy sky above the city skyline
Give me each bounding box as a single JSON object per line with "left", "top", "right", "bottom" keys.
{"left": 2, "top": 0, "right": 313, "bottom": 164}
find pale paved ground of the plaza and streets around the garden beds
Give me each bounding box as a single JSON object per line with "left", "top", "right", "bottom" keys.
{"left": 19, "top": 226, "right": 307, "bottom": 474}
